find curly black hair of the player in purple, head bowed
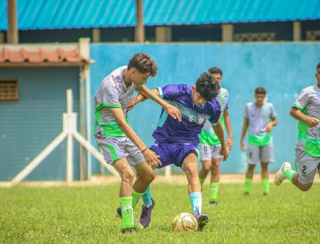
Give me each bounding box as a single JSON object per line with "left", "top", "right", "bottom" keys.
{"left": 196, "top": 72, "right": 220, "bottom": 101}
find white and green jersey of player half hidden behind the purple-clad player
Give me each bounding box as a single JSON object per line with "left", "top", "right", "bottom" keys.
{"left": 199, "top": 87, "right": 229, "bottom": 146}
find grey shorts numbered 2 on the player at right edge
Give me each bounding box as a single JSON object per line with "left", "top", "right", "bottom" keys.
{"left": 295, "top": 148, "right": 320, "bottom": 185}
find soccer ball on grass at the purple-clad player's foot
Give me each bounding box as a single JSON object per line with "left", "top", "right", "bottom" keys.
{"left": 172, "top": 213, "right": 198, "bottom": 232}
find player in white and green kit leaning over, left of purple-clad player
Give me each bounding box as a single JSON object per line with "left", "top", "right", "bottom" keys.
{"left": 94, "top": 53, "right": 181, "bottom": 233}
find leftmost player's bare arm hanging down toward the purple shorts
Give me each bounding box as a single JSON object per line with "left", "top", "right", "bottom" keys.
{"left": 109, "top": 108, "right": 161, "bottom": 168}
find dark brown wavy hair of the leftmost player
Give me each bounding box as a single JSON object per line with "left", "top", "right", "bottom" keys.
{"left": 128, "top": 53, "right": 158, "bottom": 77}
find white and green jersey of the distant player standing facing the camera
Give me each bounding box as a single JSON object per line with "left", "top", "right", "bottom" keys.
{"left": 243, "top": 102, "right": 277, "bottom": 146}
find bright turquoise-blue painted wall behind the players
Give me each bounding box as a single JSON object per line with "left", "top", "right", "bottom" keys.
{"left": 90, "top": 43, "right": 320, "bottom": 173}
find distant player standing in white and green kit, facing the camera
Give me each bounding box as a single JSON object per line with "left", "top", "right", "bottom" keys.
{"left": 240, "top": 87, "right": 278, "bottom": 196}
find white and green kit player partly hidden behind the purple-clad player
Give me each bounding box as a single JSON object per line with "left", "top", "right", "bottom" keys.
{"left": 199, "top": 67, "right": 232, "bottom": 205}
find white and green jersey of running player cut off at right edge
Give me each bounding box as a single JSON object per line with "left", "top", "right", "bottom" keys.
{"left": 292, "top": 85, "right": 320, "bottom": 157}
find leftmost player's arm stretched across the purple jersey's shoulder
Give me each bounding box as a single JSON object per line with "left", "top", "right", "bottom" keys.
{"left": 130, "top": 86, "right": 181, "bottom": 122}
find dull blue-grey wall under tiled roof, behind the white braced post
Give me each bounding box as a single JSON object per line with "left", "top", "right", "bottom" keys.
{"left": 0, "top": 67, "right": 80, "bottom": 181}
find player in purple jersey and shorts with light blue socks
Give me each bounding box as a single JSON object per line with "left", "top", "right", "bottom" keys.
{"left": 127, "top": 72, "right": 229, "bottom": 231}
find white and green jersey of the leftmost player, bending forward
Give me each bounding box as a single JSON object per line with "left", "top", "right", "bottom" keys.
{"left": 94, "top": 66, "right": 136, "bottom": 137}
